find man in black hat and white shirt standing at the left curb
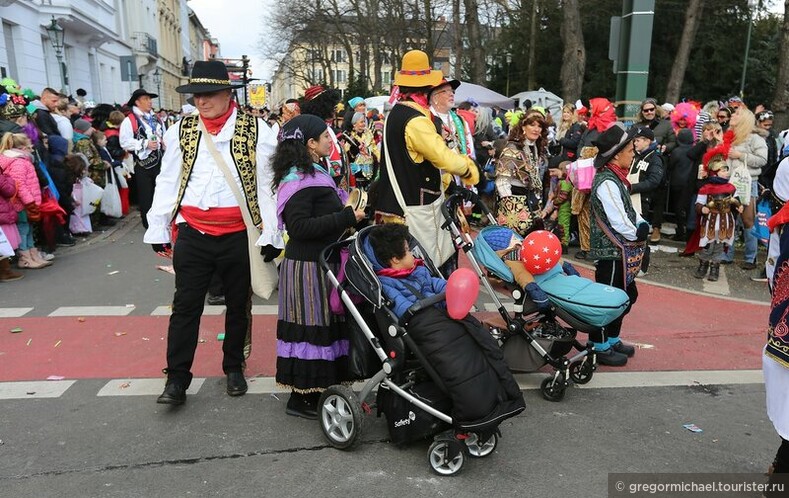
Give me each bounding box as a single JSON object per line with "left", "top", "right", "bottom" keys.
{"left": 119, "top": 88, "right": 164, "bottom": 228}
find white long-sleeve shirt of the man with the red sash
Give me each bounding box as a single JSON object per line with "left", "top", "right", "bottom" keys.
{"left": 143, "top": 111, "right": 285, "bottom": 248}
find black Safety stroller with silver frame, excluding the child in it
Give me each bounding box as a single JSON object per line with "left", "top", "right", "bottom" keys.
{"left": 318, "top": 227, "right": 525, "bottom": 475}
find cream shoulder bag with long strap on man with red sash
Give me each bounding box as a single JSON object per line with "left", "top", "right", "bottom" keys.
{"left": 198, "top": 120, "right": 279, "bottom": 299}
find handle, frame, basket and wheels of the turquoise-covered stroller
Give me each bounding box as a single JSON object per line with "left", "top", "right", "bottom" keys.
{"left": 441, "top": 189, "right": 612, "bottom": 401}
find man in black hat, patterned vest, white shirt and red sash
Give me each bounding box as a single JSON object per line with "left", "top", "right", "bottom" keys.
{"left": 144, "top": 61, "right": 284, "bottom": 405}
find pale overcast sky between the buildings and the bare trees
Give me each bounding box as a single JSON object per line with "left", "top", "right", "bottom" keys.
{"left": 189, "top": 0, "right": 274, "bottom": 81}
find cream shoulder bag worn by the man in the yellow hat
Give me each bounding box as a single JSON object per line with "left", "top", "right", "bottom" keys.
{"left": 384, "top": 118, "right": 455, "bottom": 266}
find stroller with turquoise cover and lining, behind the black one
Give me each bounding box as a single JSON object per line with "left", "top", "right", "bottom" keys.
{"left": 442, "top": 190, "right": 628, "bottom": 401}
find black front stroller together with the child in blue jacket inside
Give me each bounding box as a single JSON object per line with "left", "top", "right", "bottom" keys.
{"left": 318, "top": 224, "right": 525, "bottom": 475}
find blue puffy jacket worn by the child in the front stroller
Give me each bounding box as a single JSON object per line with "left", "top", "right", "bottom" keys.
{"left": 363, "top": 239, "right": 447, "bottom": 318}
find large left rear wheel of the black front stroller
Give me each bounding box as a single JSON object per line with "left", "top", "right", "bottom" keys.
{"left": 318, "top": 386, "right": 363, "bottom": 450}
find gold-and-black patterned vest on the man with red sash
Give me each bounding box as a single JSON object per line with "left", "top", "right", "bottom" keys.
{"left": 173, "top": 110, "right": 263, "bottom": 226}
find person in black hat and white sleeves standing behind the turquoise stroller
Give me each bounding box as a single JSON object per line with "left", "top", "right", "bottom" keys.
{"left": 589, "top": 125, "right": 649, "bottom": 366}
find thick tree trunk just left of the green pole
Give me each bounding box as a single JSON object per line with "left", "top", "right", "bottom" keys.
{"left": 560, "top": 0, "right": 586, "bottom": 102}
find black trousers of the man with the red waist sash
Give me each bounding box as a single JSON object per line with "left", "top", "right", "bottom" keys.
{"left": 167, "top": 223, "right": 252, "bottom": 386}
